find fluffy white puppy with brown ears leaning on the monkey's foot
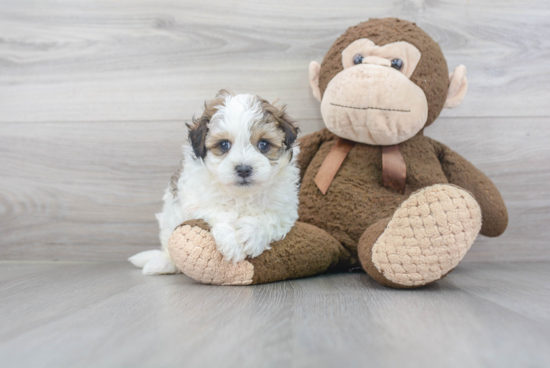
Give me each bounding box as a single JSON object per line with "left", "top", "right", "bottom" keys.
{"left": 129, "top": 90, "right": 300, "bottom": 275}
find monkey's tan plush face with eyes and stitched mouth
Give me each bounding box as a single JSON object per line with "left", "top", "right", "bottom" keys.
{"left": 321, "top": 38, "right": 428, "bottom": 145}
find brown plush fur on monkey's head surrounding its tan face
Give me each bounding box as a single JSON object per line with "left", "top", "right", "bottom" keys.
{"left": 319, "top": 18, "right": 449, "bottom": 126}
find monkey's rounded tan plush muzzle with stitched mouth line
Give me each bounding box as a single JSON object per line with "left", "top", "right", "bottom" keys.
{"left": 321, "top": 64, "right": 432, "bottom": 145}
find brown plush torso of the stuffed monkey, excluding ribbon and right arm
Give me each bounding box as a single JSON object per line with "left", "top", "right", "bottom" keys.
{"left": 299, "top": 129, "right": 448, "bottom": 254}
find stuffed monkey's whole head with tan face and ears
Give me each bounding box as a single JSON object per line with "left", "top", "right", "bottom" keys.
{"left": 309, "top": 18, "right": 468, "bottom": 145}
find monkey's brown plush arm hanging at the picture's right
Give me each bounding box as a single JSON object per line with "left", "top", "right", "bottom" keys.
{"left": 431, "top": 140, "right": 508, "bottom": 237}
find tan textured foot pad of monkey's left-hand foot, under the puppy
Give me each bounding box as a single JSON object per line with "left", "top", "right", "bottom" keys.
{"left": 168, "top": 225, "right": 254, "bottom": 285}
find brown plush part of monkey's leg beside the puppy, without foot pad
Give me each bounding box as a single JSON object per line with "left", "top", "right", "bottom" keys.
{"left": 247, "top": 222, "right": 349, "bottom": 284}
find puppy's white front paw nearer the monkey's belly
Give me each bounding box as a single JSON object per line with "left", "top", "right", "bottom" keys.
{"left": 235, "top": 216, "right": 270, "bottom": 258}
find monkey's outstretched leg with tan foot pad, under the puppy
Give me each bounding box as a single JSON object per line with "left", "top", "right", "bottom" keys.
{"left": 168, "top": 220, "right": 349, "bottom": 285}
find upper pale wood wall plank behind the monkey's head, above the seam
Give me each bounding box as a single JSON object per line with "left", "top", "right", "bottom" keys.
{"left": 0, "top": 0, "right": 550, "bottom": 122}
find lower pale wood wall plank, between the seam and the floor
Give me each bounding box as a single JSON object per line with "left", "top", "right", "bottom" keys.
{"left": 0, "top": 118, "right": 550, "bottom": 261}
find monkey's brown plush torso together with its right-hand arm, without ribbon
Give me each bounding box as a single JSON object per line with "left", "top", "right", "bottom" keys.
{"left": 299, "top": 129, "right": 507, "bottom": 255}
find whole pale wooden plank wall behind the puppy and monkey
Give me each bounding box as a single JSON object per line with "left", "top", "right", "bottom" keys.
{"left": 0, "top": 0, "right": 550, "bottom": 261}
